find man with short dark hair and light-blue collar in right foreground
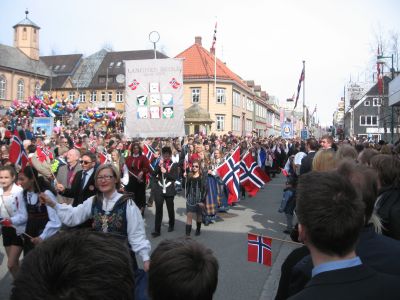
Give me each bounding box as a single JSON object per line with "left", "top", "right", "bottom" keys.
{"left": 290, "top": 172, "right": 400, "bottom": 300}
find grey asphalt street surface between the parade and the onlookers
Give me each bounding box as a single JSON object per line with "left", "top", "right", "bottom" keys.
{"left": 0, "top": 175, "right": 296, "bottom": 300}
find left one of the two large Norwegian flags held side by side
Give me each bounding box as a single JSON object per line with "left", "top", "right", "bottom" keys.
{"left": 216, "top": 147, "right": 241, "bottom": 204}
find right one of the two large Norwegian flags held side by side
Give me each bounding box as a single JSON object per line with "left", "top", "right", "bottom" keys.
{"left": 240, "top": 151, "right": 271, "bottom": 196}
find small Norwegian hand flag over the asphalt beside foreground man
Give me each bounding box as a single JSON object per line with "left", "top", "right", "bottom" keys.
{"left": 247, "top": 233, "right": 272, "bottom": 267}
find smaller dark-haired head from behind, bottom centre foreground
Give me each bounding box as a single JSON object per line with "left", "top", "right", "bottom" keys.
{"left": 149, "top": 238, "right": 219, "bottom": 300}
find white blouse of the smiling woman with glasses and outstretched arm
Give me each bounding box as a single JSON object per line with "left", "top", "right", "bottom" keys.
{"left": 54, "top": 191, "right": 151, "bottom": 261}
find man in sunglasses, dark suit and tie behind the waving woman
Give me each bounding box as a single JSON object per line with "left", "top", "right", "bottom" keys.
{"left": 56, "top": 149, "right": 96, "bottom": 207}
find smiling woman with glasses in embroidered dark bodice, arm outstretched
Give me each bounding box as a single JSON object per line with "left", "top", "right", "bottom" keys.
{"left": 41, "top": 164, "right": 150, "bottom": 271}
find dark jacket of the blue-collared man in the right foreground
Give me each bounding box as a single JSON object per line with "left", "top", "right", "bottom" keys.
{"left": 289, "top": 265, "right": 400, "bottom": 300}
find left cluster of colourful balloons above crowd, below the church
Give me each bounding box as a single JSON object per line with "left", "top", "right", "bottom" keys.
{"left": 7, "top": 94, "right": 79, "bottom": 118}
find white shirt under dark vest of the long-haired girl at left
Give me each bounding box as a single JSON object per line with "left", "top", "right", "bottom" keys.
{"left": 11, "top": 190, "right": 61, "bottom": 240}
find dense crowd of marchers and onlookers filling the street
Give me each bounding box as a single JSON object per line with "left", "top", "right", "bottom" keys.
{"left": 0, "top": 114, "right": 400, "bottom": 299}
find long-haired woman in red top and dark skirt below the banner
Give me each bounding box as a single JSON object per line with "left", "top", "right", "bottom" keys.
{"left": 125, "top": 143, "right": 150, "bottom": 216}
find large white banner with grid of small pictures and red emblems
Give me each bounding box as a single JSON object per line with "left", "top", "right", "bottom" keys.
{"left": 125, "top": 58, "right": 185, "bottom": 138}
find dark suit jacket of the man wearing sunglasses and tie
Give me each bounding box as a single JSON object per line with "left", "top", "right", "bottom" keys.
{"left": 61, "top": 170, "right": 97, "bottom": 206}
